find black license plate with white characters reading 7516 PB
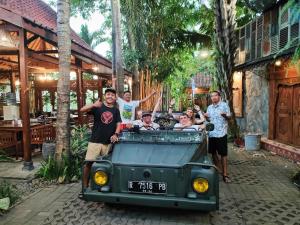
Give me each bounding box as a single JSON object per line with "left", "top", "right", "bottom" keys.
{"left": 128, "top": 181, "right": 167, "bottom": 194}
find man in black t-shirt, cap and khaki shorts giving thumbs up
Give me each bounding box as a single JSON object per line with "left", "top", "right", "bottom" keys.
{"left": 80, "top": 89, "right": 122, "bottom": 188}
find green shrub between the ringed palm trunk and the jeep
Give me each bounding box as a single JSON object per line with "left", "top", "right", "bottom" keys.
{"left": 37, "top": 126, "right": 89, "bottom": 183}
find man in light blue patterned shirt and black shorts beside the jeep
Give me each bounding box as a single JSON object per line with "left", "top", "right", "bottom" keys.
{"left": 204, "top": 91, "right": 231, "bottom": 183}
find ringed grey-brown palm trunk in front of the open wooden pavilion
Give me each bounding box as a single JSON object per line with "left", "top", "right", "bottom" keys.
{"left": 55, "top": 0, "right": 71, "bottom": 161}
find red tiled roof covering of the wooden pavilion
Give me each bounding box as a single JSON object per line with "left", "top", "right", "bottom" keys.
{"left": 0, "top": 0, "right": 92, "bottom": 50}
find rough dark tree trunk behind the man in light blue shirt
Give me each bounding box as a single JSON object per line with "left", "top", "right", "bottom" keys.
{"left": 214, "top": 0, "right": 238, "bottom": 136}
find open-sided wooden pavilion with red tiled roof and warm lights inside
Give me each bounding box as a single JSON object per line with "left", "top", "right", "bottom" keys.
{"left": 0, "top": 0, "right": 129, "bottom": 169}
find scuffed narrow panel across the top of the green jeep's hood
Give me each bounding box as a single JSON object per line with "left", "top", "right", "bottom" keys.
{"left": 120, "top": 130, "right": 203, "bottom": 143}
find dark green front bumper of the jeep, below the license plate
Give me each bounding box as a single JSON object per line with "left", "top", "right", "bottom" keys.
{"left": 83, "top": 189, "right": 219, "bottom": 211}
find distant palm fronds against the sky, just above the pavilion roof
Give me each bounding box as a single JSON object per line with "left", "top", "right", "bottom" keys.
{"left": 79, "top": 24, "right": 104, "bottom": 49}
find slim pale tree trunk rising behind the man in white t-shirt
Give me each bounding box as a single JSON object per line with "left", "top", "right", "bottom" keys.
{"left": 111, "top": 0, "right": 125, "bottom": 96}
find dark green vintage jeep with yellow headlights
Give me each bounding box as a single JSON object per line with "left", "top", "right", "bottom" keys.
{"left": 82, "top": 130, "right": 219, "bottom": 211}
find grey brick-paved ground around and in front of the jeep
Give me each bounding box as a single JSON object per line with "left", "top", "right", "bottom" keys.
{"left": 0, "top": 147, "right": 300, "bottom": 225}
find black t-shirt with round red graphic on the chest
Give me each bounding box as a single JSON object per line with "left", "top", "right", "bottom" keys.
{"left": 90, "top": 104, "right": 122, "bottom": 144}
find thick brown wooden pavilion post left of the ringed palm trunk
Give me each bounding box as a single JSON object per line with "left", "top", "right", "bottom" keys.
{"left": 19, "top": 29, "right": 34, "bottom": 170}
